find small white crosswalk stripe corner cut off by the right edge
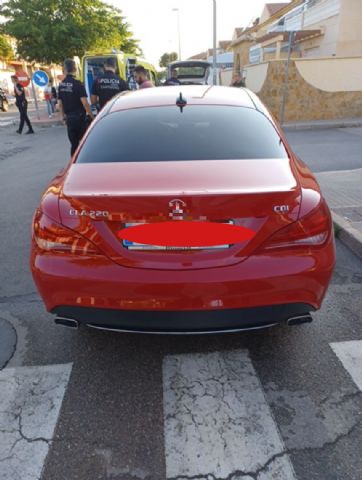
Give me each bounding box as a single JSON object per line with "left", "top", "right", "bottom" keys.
{"left": 330, "top": 340, "right": 362, "bottom": 391}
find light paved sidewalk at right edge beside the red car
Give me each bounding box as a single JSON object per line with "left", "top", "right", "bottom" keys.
{"left": 316, "top": 168, "right": 362, "bottom": 258}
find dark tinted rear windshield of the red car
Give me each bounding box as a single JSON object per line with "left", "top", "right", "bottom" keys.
{"left": 77, "top": 105, "right": 287, "bottom": 163}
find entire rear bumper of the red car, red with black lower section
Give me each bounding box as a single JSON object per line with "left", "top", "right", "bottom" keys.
{"left": 31, "top": 232, "right": 335, "bottom": 333}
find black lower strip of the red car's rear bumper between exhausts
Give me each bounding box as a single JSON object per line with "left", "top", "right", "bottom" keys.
{"left": 52, "top": 303, "right": 314, "bottom": 334}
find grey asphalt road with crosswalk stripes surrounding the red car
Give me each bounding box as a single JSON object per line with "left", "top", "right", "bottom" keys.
{"left": 0, "top": 127, "right": 362, "bottom": 480}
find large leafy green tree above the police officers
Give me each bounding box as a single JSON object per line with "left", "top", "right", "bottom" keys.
{"left": 0, "top": 0, "right": 139, "bottom": 64}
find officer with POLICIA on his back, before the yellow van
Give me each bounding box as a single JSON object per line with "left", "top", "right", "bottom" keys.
{"left": 91, "top": 57, "right": 128, "bottom": 108}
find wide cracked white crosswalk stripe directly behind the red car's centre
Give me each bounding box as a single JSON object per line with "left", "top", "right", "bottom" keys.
{"left": 163, "top": 350, "right": 296, "bottom": 480}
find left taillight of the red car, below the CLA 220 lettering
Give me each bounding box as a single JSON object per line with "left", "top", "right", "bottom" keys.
{"left": 33, "top": 210, "right": 101, "bottom": 255}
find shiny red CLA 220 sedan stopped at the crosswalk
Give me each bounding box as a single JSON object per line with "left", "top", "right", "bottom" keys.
{"left": 31, "top": 85, "right": 335, "bottom": 333}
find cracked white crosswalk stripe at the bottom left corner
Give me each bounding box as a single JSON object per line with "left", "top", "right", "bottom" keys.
{"left": 0, "top": 364, "right": 72, "bottom": 480}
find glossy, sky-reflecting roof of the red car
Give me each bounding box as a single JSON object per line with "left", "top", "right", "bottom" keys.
{"left": 108, "top": 85, "right": 256, "bottom": 113}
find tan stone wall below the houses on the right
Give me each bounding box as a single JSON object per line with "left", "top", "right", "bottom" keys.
{"left": 246, "top": 57, "right": 362, "bottom": 122}
